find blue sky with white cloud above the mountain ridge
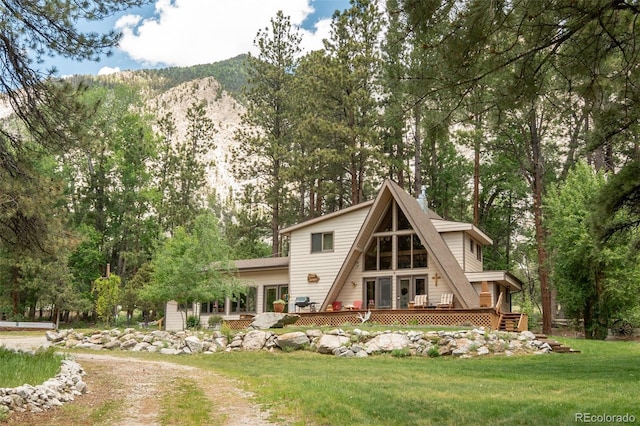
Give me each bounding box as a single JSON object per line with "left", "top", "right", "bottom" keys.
{"left": 45, "top": 0, "right": 349, "bottom": 76}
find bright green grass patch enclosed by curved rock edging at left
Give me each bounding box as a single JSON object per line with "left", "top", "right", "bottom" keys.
{"left": 0, "top": 346, "right": 63, "bottom": 388}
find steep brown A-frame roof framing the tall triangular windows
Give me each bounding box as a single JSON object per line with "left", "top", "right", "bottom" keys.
{"left": 321, "top": 179, "right": 479, "bottom": 309}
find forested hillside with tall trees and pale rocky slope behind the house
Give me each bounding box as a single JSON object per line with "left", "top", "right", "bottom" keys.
{"left": 0, "top": 0, "right": 640, "bottom": 338}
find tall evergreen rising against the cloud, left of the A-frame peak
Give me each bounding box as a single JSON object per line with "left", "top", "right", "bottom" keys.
{"left": 234, "top": 11, "right": 301, "bottom": 256}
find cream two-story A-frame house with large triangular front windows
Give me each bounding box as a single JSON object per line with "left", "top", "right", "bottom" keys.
{"left": 165, "top": 180, "right": 521, "bottom": 329}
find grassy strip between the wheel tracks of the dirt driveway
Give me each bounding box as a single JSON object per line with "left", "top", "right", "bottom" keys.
{"left": 158, "top": 378, "right": 212, "bottom": 426}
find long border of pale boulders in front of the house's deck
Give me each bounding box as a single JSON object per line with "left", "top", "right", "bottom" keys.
{"left": 46, "top": 328, "right": 553, "bottom": 358}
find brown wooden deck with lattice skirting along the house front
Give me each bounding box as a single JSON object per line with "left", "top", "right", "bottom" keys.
{"left": 225, "top": 308, "right": 500, "bottom": 330}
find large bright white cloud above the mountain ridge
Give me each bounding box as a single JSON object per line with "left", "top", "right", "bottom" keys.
{"left": 116, "top": 0, "right": 330, "bottom": 66}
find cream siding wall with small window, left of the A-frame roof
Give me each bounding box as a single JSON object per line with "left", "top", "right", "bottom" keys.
{"left": 289, "top": 209, "right": 368, "bottom": 307}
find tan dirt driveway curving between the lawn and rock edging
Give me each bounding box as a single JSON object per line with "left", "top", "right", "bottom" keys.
{"left": 0, "top": 336, "right": 273, "bottom": 426}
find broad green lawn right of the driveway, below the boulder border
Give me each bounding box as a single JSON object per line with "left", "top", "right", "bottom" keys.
{"left": 174, "top": 339, "right": 640, "bottom": 425}
